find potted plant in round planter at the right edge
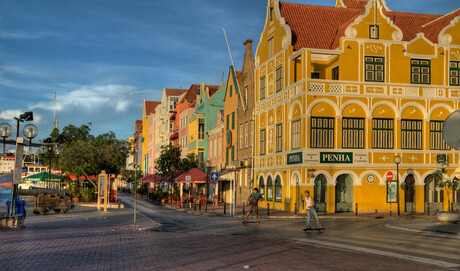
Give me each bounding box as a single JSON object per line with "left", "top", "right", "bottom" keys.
{"left": 433, "top": 166, "right": 460, "bottom": 223}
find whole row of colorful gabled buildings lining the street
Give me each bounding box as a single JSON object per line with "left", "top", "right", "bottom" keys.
{"left": 128, "top": 0, "right": 460, "bottom": 215}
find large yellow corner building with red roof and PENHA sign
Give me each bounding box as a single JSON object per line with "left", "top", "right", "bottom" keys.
{"left": 254, "top": 0, "right": 460, "bottom": 215}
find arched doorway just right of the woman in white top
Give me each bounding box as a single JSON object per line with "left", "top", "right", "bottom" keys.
{"left": 335, "top": 174, "right": 353, "bottom": 213}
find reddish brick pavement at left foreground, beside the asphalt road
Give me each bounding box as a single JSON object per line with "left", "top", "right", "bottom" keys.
{"left": 0, "top": 199, "right": 456, "bottom": 270}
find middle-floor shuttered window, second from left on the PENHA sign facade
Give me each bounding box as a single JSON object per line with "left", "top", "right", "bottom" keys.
{"left": 342, "top": 118, "right": 364, "bottom": 149}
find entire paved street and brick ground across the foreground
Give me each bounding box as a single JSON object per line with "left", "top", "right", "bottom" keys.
{"left": 0, "top": 197, "right": 460, "bottom": 270}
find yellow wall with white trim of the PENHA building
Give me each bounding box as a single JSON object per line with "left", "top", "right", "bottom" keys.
{"left": 254, "top": 1, "right": 460, "bottom": 213}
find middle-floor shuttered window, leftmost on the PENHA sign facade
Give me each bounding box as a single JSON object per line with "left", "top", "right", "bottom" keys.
{"left": 310, "top": 117, "right": 335, "bottom": 149}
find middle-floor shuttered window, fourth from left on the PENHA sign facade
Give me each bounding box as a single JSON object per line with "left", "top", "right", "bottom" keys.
{"left": 401, "top": 120, "right": 423, "bottom": 150}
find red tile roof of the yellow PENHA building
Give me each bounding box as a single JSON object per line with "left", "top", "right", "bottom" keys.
{"left": 280, "top": 0, "right": 452, "bottom": 51}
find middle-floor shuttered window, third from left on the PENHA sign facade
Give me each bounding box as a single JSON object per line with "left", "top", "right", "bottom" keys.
{"left": 372, "top": 119, "right": 394, "bottom": 149}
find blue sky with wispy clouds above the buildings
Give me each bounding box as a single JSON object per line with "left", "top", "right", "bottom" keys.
{"left": 0, "top": 0, "right": 460, "bottom": 142}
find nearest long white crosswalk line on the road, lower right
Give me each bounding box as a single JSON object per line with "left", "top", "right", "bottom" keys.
{"left": 290, "top": 238, "right": 460, "bottom": 268}
